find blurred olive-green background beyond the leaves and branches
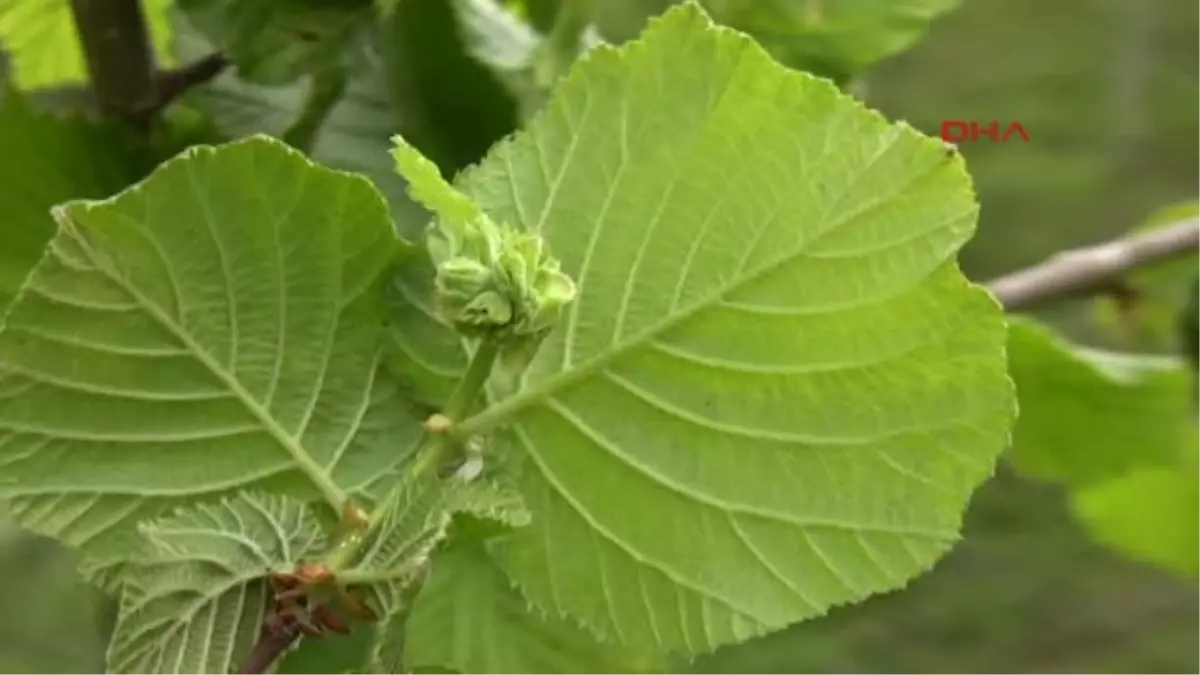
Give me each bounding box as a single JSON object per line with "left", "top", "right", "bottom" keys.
{"left": 0, "top": 0, "right": 1200, "bottom": 675}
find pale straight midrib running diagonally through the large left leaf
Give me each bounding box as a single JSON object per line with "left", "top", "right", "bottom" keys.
{"left": 55, "top": 214, "right": 346, "bottom": 509}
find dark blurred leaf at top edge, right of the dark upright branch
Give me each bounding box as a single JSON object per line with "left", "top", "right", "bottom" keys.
{"left": 178, "top": 0, "right": 374, "bottom": 84}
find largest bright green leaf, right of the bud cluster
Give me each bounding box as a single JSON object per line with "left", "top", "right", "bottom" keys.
{"left": 391, "top": 4, "right": 1015, "bottom": 652}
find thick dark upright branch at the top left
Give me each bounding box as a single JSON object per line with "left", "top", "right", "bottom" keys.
{"left": 71, "top": 0, "right": 156, "bottom": 129}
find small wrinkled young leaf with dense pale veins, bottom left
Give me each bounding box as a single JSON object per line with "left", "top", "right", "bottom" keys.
{"left": 108, "top": 492, "right": 325, "bottom": 675}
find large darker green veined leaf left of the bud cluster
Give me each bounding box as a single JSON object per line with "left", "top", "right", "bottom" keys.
{"left": 0, "top": 137, "right": 420, "bottom": 571}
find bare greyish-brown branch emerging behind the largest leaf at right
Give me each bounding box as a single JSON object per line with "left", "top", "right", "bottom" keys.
{"left": 988, "top": 219, "right": 1200, "bottom": 311}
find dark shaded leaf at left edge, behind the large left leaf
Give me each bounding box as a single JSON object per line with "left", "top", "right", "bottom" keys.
{"left": 0, "top": 86, "right": 147, "bottom": 315}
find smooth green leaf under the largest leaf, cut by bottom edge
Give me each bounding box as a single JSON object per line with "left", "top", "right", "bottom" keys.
{"left": 407, "top": 545, "right": 664, "bottom": 675}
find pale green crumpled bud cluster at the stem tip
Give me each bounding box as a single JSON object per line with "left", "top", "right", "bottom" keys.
{"left": 428, "top": 214, "right": 575, "bottom": 345}
